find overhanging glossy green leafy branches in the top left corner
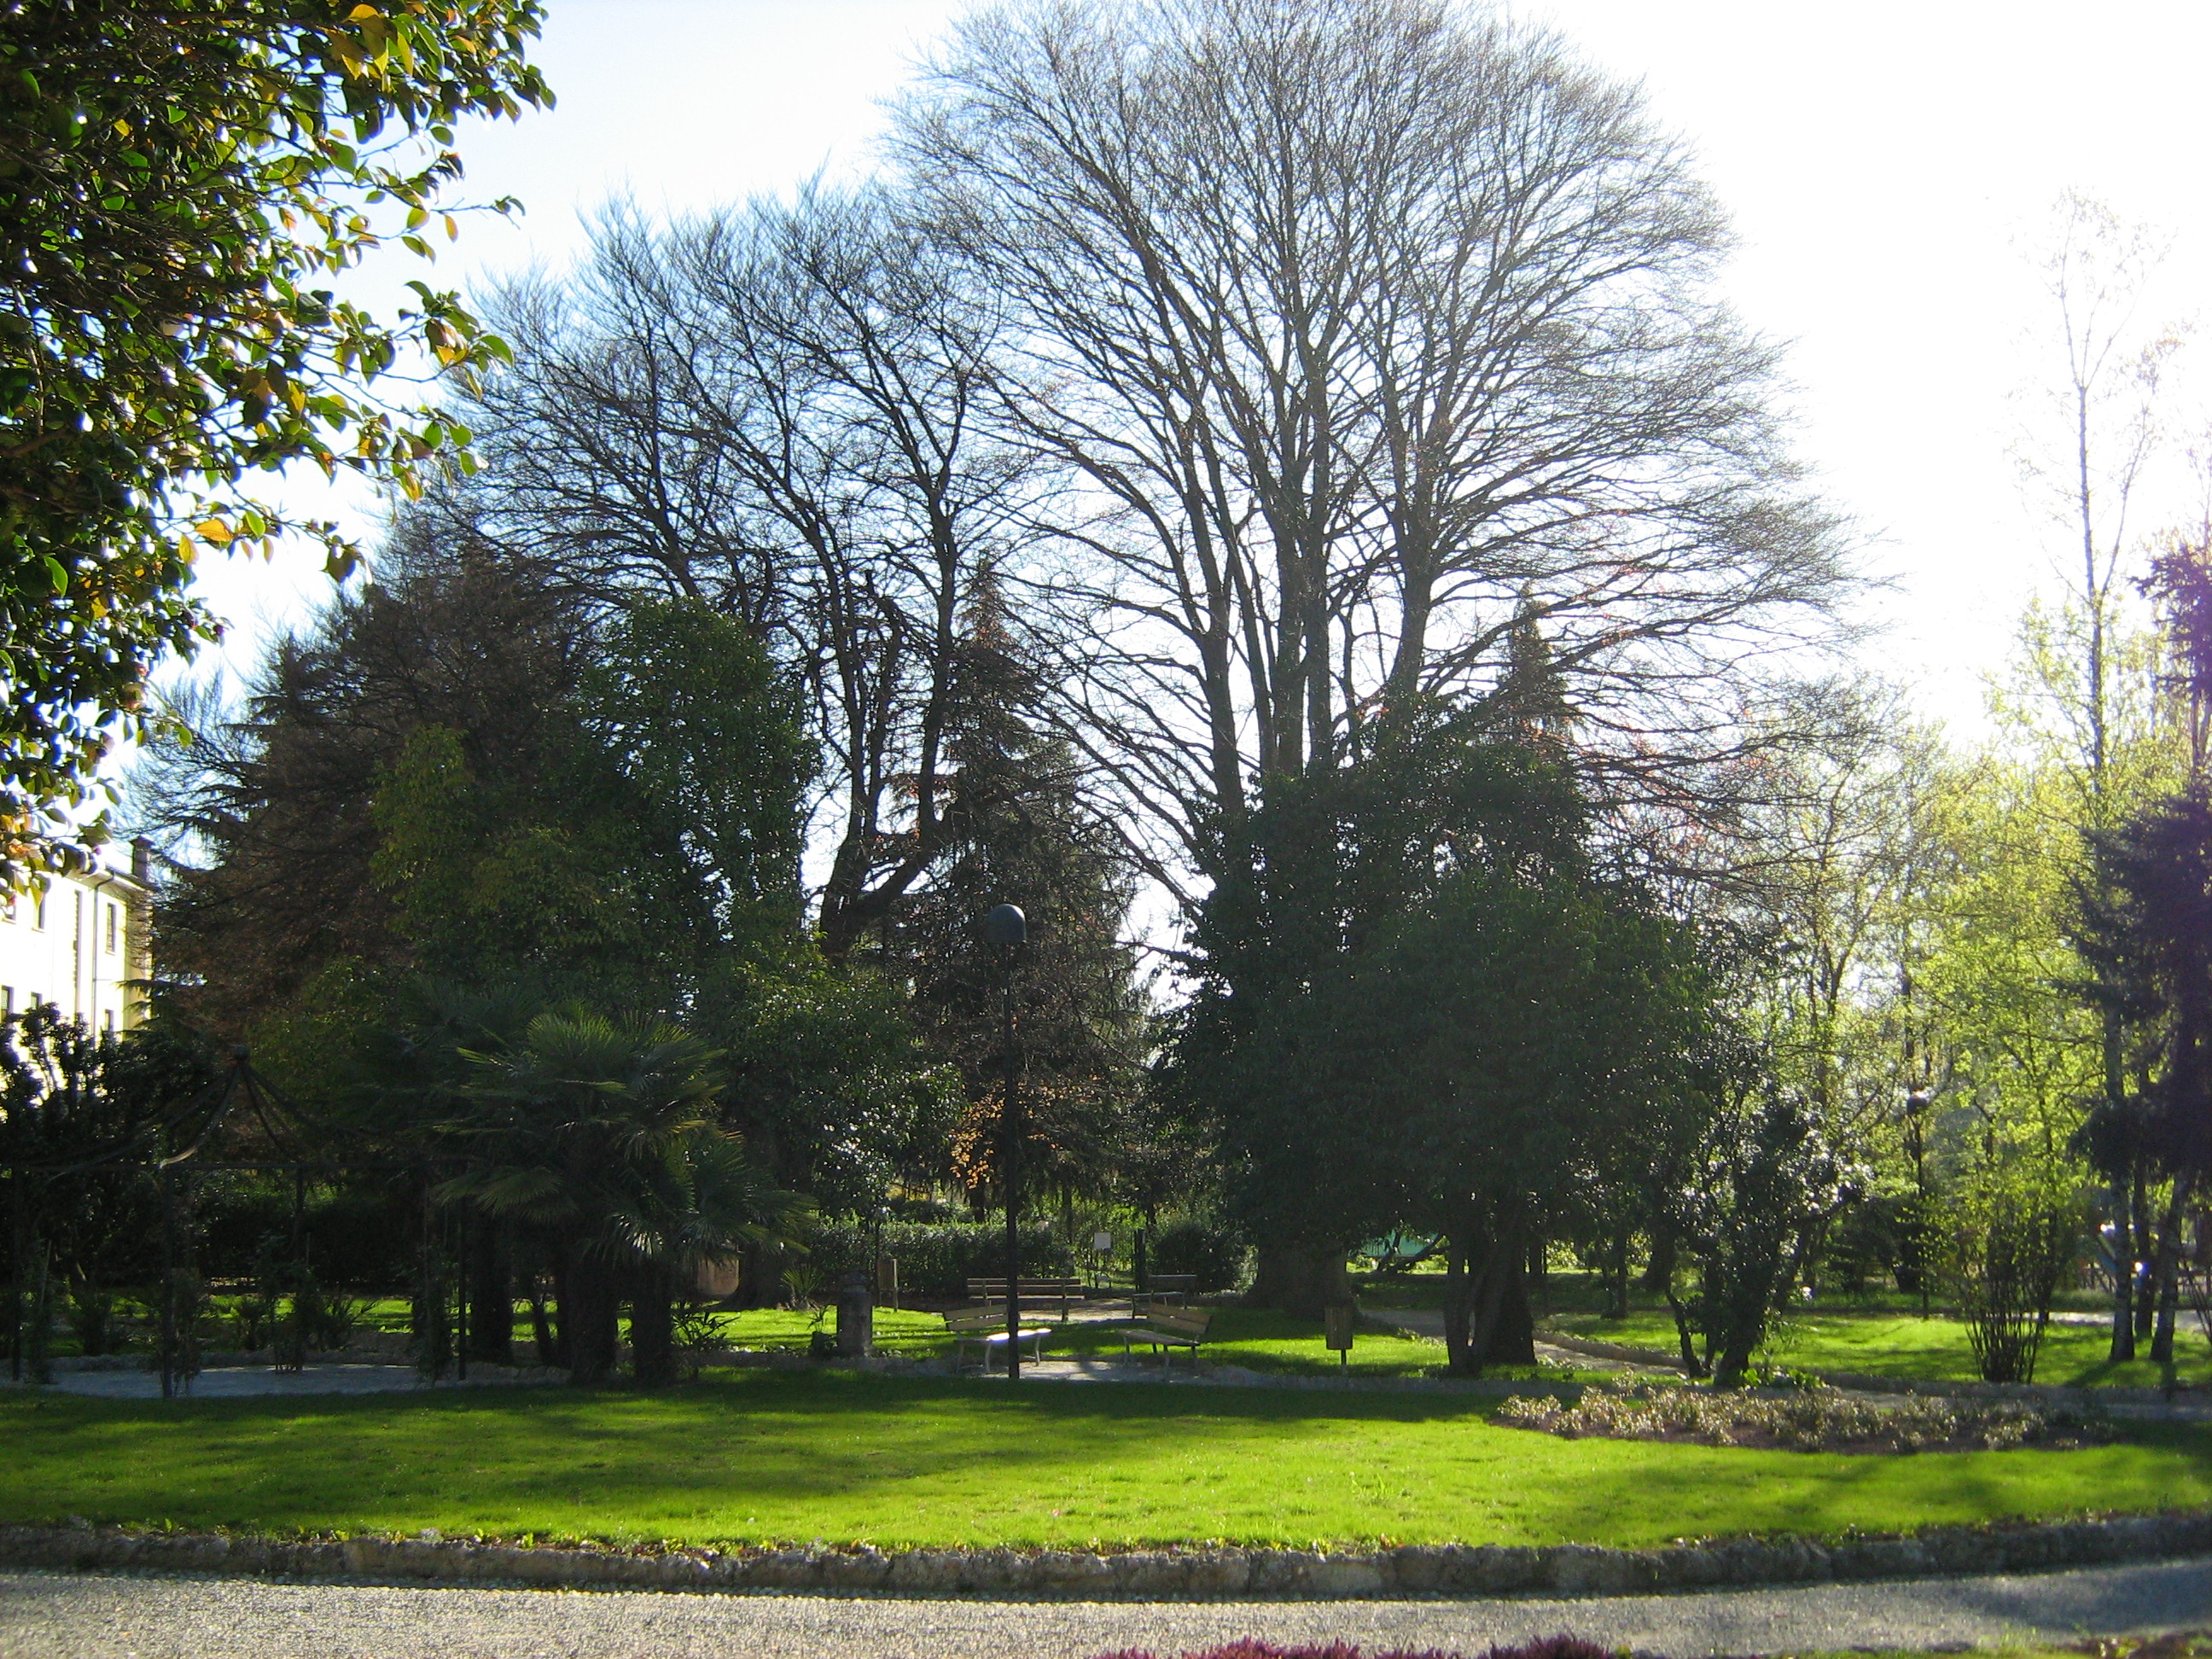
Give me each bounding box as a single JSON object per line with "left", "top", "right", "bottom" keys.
{"left": 0, "top": 0, "right": 550, "bottom": 870}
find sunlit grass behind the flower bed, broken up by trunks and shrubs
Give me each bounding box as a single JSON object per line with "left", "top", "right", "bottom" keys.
{"left": 1551, "top": 1309, "right": 2212, "bottom": 1387}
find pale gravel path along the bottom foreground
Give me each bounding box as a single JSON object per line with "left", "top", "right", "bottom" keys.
{"left": 0, "top": 1562, "right": 2212, "bottom": 1659}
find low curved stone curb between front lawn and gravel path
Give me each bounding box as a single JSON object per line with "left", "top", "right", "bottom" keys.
{"left": 0, "top": 1511, "right": 2212, "bottom": 1602}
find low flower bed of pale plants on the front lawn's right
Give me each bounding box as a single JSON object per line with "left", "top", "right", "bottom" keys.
{"left": 1498, "top": 1385, "right": 2112, "bottom": 1453}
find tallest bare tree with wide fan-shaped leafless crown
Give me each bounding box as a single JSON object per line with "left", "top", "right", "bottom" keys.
{"left": 898, "top": 0, "right": 1842, "bottom": 911}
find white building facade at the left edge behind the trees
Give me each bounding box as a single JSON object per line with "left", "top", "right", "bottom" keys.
{"left": 0, "top": 849, "right": 153, "bottom": 1031}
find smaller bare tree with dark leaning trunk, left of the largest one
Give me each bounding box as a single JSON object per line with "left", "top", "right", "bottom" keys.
{"left": 463, "top": 190, "right": 1022, "bottom": 956}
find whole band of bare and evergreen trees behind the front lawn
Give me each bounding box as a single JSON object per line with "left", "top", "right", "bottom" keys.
{"left": 9, "top": 0, "right": 2212, "bottom": 1406}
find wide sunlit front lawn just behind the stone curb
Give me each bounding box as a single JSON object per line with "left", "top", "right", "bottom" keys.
{"left": 0, "top": 1371, "right": 2212, "bottom": 1546}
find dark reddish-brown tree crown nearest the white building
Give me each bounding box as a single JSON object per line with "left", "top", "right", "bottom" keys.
{"left": 159, "top": 524, "right": 584, "bottom": 1039}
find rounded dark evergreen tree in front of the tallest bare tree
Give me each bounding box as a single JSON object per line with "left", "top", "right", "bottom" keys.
{"left": 1173, "top": 714, "right": 1708, "bottom": 1369}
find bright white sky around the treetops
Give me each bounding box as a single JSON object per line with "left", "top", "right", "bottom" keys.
{"left": 185, "top": 0, "right": 2212, "bottom": 728}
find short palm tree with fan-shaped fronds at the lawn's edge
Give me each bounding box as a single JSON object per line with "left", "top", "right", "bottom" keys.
{"left": 440, "top": 1009, "right": 805, "bottom": 1385}
